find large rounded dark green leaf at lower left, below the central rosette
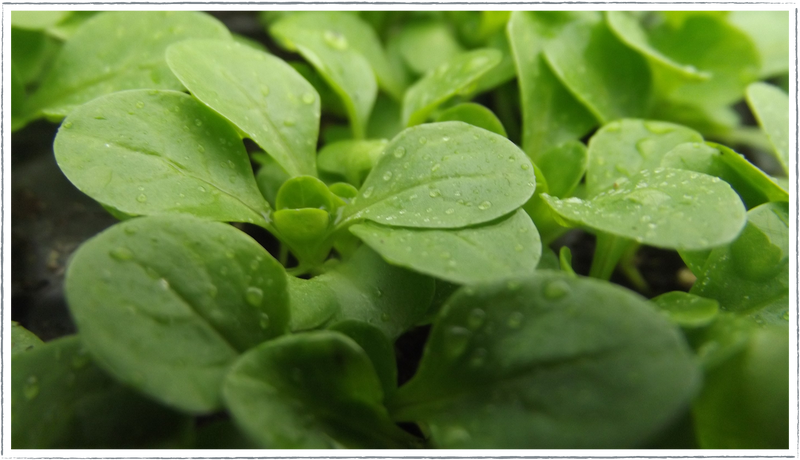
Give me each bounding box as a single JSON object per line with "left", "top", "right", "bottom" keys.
{"left": 65, "top": 216, "right": 289, "bottom": 413}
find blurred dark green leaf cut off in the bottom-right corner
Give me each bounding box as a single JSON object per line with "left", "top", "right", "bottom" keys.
{"left": 693, "top": 326, "right": 793, "bottom": 452}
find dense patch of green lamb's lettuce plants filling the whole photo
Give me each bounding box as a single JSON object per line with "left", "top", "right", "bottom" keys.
{"left": 9, "top": 9, "right": 792, "bottom": 452}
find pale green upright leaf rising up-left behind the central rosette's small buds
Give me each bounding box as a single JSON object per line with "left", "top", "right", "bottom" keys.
{"left": 166, "top": 40, "right": 320, "bottom": 177}
